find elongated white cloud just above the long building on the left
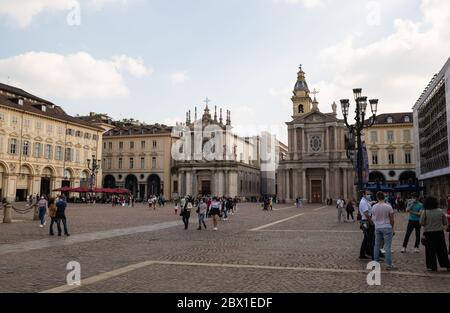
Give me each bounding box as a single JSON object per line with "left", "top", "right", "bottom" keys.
{"left": 0, "top": 52, "right": 151, "bottom": 100}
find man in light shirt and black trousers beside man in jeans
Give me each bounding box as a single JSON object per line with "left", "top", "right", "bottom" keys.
{"left": 358, "top": 191, "right": 375, "bottom": 260}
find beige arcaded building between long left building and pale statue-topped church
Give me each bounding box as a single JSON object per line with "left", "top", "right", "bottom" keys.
{"left": 102, "top": 122, "right": 178, "bottom": 199}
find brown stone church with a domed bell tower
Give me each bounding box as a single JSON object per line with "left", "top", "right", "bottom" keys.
{"left": 277, "top": 68, "right": 355, "bottom": 203}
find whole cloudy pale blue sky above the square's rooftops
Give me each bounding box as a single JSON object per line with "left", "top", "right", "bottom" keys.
{"left": 0, "top": 0, "right": 450, "bottom": 141}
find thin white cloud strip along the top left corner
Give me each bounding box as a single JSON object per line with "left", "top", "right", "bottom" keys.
{"left": 0, "top": 0, "right": 128, "bottom": 28}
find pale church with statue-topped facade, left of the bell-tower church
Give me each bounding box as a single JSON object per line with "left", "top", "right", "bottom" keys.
{"left": 174, "top": 101, "right": 261, "bottom": 198}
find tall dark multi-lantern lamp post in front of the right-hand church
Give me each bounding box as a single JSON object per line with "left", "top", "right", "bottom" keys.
{"left": 341, "top": 88, "right": 378, "bottom": 192}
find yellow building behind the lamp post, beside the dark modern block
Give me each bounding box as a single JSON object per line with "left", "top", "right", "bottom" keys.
{"left": 364, "top": 112, "right": 416, "bottom": 187}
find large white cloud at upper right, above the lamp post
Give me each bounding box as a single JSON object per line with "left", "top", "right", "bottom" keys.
{"left": 310, "top": 0, "right": 450, "bottom": 112}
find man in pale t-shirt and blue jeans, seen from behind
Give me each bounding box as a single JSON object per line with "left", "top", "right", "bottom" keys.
{"left": 372, "top": 191, "right": 395, "bottom": 271}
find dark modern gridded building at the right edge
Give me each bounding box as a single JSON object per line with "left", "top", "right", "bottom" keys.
{"left": 413, "top": 59, "right": 450, "bottom": 200}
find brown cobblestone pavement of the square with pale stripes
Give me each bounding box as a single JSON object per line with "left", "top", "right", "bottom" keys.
{"left": 0, "top": 204, "right": 450, "bottom": 292}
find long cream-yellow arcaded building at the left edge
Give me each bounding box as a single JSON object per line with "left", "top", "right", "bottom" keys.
{"left": 0, "top": 84, "right": 104, "bottom": 201}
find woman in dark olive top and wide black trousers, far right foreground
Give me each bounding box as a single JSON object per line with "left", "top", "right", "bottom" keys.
{"left": 420, "top": 197, "right": 450, "bottom": 272}
